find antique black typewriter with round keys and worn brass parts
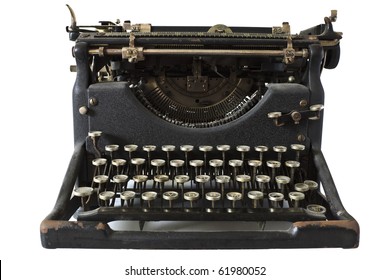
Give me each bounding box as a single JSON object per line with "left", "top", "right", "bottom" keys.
{"left": 40, "top": 6, "right": 359, "bottom": 249}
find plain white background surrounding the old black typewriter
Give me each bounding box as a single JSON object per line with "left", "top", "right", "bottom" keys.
{"left": 0, "top": 0, "right": 390, "bottom": 280}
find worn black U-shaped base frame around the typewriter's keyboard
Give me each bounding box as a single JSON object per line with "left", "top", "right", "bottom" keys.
{"left": 41, "top": 144, "right": 359, "bottom": 249}
